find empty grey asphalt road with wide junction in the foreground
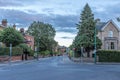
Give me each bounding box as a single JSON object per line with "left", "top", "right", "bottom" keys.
{"left": 0, "top": 56, "right": 120, "bottom": 80}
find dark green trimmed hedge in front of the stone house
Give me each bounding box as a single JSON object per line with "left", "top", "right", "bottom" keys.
{"left": 97, "top": 50, "right": 120, "bottom": 62}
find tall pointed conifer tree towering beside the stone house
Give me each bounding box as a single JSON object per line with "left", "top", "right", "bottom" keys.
{"left": 73, "top": 4, "right": 102, "bottom": 57}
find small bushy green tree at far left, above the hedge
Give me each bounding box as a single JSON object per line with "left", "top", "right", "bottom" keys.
{"left": 0, "top": 27, "right": 24, "bottom": 47}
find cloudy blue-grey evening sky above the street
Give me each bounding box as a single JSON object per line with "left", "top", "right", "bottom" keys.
{"left": 0, "top": 0, "right": 120, "bottom": 46}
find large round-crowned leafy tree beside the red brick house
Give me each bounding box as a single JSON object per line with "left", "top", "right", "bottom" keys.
{"left": 27, "top": 21, "right": 56, "bottom": 51}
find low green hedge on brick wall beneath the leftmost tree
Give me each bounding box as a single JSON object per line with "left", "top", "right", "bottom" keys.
{"left": 0, "top": 47, "right": 23, "bottom": 56}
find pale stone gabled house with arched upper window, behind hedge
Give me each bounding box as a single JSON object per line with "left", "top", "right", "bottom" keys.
{"left": 96, "top": 20, "right": 120, "bottom": 50}
